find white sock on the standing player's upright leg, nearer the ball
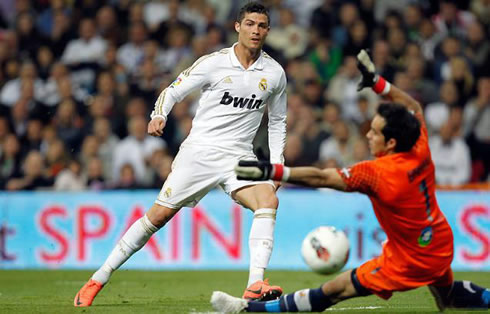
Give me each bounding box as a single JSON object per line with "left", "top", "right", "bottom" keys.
{"left": 247, "top": 208, "right": 276, "bottom": 287}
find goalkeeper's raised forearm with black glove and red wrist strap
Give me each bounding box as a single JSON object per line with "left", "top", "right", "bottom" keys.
{"left": 357, "top": 49, "right": 422, "bottom": 113}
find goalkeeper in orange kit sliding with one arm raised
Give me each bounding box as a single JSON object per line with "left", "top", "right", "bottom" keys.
{"left": 211, "top": 50, "right": 490, "bottom": 312}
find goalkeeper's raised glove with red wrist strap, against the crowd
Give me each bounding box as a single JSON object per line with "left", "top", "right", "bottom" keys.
{"left": 357, "top": 49, "right": 391, "bottom": 95}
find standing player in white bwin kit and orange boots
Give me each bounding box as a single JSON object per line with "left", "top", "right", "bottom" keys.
{"left": 74, "top": 2, "right": 287, "bottom": 306}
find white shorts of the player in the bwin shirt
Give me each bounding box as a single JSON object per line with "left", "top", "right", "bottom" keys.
{"left": 155, "top": 145, "right": 274, "bottom": 209}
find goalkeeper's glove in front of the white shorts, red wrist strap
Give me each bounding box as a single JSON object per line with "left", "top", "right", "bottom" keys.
{"left": 235, "top": 160, "right": 289, "bottom": 181}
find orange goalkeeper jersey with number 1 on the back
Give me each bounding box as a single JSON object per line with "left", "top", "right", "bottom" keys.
{"left": 338, "top": 114, "right": 453, "bottom": 277}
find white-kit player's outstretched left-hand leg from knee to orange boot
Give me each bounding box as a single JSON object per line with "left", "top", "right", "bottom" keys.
{"left": 74, "top": 203, "right": 178, "bottom": 306}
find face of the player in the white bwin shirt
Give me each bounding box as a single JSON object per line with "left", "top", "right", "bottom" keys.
{"left": 235, "top": 12, "right": 270, "bottom": 50}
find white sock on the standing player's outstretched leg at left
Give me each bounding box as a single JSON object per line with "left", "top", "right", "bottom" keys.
{"left": 92, "top": 215, "right": 159, "bottom": 284}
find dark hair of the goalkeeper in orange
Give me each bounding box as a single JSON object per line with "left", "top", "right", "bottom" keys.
{"left": 378, "top": 103, "right": 420, "bottom": 153}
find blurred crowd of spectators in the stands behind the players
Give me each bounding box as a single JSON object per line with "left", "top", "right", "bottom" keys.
{"left": 0, "top": 0, "right": 490, "bottom": 191}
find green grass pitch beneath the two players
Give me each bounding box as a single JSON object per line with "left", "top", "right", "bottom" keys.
{"left": 0, "top": 270, "right": 490, "bottom": 314}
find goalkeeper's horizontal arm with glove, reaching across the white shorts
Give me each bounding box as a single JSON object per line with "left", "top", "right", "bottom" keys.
{"left": 235, "top": 160, "right": 347, "bottom": 191}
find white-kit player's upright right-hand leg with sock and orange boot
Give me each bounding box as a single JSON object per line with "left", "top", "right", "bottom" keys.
{"left": 232, "top": 181, "right": 282, "bottom": 301}
